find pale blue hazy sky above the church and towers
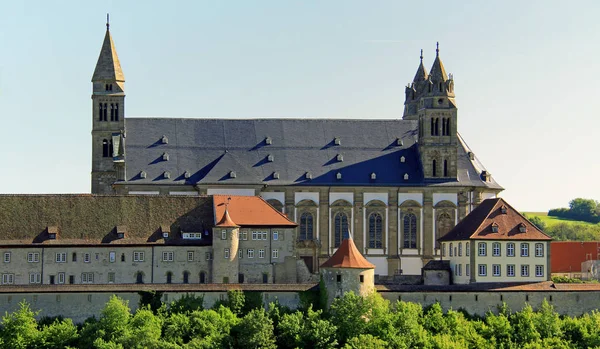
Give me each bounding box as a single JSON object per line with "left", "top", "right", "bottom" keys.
{"left": 0, "top": 0, "right": 600, "bottom": 211}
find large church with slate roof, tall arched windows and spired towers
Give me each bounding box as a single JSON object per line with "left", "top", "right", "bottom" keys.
{"left": 91, "top": 24, "right": 502, "bottom": 279}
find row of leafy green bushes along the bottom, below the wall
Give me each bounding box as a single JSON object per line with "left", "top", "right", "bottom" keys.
{"left": 5, "top": 291, "right": 600, "bottom": 349}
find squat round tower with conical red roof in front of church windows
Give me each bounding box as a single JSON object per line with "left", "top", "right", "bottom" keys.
{"left": 321, "top": 238, "right": 375, "bottom": 306}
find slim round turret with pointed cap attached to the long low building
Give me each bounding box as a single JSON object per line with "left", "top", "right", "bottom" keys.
{"left": 212, "top": 209, "right": 240, "bottom": 284}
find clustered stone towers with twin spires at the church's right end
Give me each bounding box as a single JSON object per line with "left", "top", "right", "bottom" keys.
{"left": 403, "top": 45, "right": 458, "bottom": 179}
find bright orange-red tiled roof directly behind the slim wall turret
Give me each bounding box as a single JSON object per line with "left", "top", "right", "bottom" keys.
{"left": 213, "top": 195, "right": 297, "bottom": 228}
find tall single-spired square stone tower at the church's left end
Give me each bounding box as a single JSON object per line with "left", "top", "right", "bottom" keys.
{"left": 92, "top": 16, "right": 125, "bottom": 194}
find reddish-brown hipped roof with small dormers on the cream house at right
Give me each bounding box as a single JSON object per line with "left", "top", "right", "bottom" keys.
{"left": 438, "top": 198, "right": 552, "bottom": 241}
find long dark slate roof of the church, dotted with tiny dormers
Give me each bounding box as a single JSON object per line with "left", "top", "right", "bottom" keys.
{"left": 117, "top": 117, "right": 502, "bottom": 189}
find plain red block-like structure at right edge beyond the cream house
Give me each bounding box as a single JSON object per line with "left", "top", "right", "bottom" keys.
{"left": 550, "top": 241, "right": 600, "bottom": 273}
